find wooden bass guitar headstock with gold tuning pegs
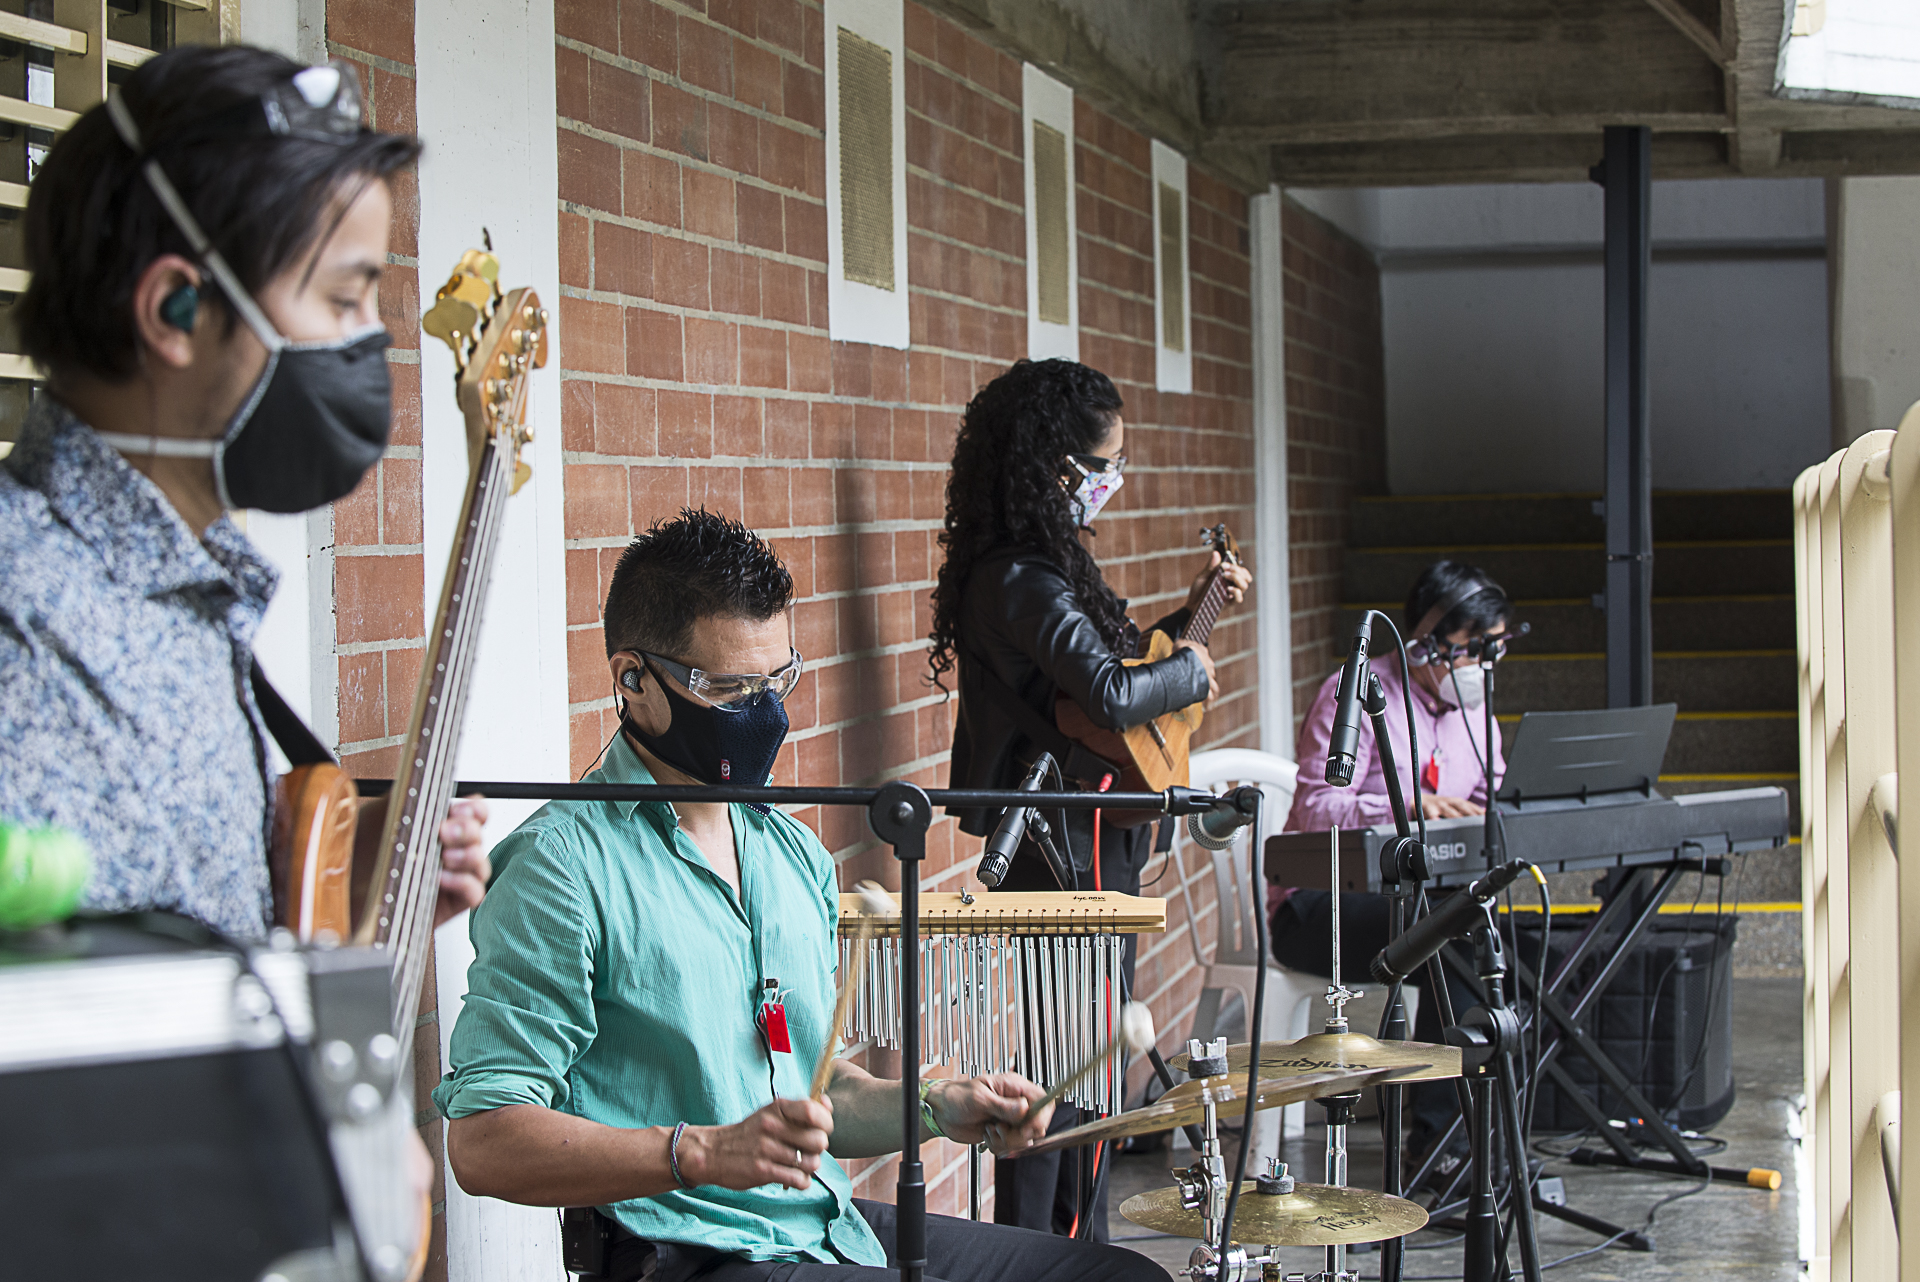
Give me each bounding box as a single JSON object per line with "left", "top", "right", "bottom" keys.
{"left": 420, "top": 249, "right": 547, "bottom": 489}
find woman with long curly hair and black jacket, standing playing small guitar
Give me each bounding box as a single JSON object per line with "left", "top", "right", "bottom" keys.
{"left": 929, "top": 361, "right": 1248, "bottom": 1240}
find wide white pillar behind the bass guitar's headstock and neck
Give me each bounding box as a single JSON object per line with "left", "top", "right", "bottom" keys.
{"left": 415, "top": 0, "right": 566, "bottom": 1282}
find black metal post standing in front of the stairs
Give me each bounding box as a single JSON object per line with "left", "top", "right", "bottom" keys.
{"left": 1594, "top": 125, "right": 1653, "bottom": 708}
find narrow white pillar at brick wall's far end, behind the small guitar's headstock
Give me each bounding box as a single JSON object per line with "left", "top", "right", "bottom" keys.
{"left": 1248, "top": 184, "right": 1294, "bottom": 760}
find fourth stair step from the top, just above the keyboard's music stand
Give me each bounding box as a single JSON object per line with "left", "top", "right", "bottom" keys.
{"left": 1494, "top": 651, "right": 1797, "bottom": 712}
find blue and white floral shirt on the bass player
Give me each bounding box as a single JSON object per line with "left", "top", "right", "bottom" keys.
{"left": 0, "top": 395, "right": 276, "bottom": 938}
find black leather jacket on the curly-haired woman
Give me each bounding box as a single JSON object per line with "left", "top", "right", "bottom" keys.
{"left": 950, "top": 549, "right": 1206, "bottom": 837}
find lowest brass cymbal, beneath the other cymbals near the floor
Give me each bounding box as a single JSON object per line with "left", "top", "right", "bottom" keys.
{"left": 1119, "top": 1180, "right": 1427, "bottom": 1246}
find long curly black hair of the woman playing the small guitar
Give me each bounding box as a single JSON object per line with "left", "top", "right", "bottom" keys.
{"left": 927, "top": 359, "right": 1129, "bottom": 691}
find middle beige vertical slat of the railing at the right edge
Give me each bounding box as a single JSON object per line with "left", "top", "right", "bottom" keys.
{"left": 1828, "top": 432, "right": 1901, "bottom": 1278}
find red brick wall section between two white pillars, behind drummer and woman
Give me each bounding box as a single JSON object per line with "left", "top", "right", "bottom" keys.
{"left": 555, "top": 0, "right": 1256, "bottom": 1211}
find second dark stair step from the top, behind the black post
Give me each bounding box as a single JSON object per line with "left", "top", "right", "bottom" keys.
{"left": 1340, "top": 539, "right": 1793, "bottom": 601}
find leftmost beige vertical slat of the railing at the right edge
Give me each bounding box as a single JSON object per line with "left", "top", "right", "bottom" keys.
{"left": 1793, "top": 454, "right": 1834, "bottom": 1282}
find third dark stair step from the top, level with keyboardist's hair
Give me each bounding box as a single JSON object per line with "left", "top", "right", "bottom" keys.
{"left": 1336, "top": 595, "right": 1793, "bottom": 654}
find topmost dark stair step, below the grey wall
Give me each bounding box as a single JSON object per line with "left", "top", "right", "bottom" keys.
{"left": 1350, "top": 489, "right": 1793, "bottom": 547}
